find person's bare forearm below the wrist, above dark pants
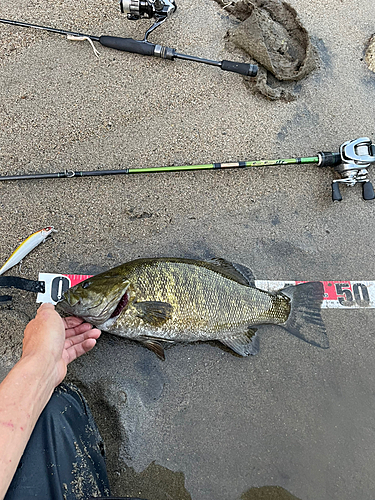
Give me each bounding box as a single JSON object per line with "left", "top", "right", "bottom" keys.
{"left": 0, "top": 356, "right": 55, "bottom": 500}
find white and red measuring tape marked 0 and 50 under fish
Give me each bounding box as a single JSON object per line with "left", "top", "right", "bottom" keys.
{"left": 37, "top": 273, "right": 375, "bottom": 309}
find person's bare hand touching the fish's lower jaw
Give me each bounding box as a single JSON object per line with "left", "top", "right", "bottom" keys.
{"left": 22, "top": 304, "right": 101, "bottom": 386}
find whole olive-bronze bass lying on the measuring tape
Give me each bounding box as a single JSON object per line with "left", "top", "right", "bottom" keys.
{"left": 57, "top": 257, "right": 329, "bottom": 359}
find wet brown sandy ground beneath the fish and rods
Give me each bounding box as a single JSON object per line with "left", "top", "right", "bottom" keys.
{"left": 0, "top": 0, "right": 375, "bottom": 500}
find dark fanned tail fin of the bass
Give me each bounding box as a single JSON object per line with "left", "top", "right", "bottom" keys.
{"left": 280, "top": 281, "right": 329, "bottom": 349}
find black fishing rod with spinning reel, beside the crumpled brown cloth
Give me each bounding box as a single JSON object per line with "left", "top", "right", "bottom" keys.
{"left": 0, "top": 0, "right": 258, "bottom": 76}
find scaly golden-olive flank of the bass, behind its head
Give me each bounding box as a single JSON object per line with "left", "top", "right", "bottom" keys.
{"left": 116, "top": 260, "right": 289, "bottom": 340}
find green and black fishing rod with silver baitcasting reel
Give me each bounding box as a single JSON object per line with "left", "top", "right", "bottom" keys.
{"left": 0, "top": 137, "right": 375, "bottom": 201}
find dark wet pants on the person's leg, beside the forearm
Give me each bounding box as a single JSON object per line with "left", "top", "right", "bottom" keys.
{"left": 5, "top": 384, "right": 110, "bottom": 500}
